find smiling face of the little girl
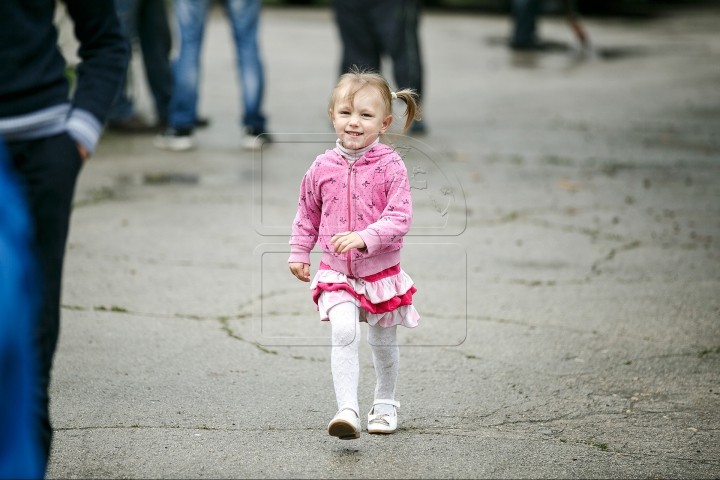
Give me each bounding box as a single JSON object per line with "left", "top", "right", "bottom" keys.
{"left": 328, "top": 87, "right": 392, "bottom": 150}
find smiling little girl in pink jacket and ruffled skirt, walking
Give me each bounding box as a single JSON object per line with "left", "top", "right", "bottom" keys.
{"left": 288, "top": 70, "right": 420, "bottom": 440}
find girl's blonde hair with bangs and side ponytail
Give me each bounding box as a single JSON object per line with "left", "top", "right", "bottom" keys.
{"left": 328, "top": 65, "right": 420, "bottom": 132}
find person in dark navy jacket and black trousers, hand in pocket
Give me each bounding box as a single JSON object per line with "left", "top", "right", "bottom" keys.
{"left": 0, "top": 0, "right": 127, "bottom": 470}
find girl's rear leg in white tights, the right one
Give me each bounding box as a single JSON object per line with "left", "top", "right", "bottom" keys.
{"left": 368, "top": 325, "right": 400, "bottom": 415}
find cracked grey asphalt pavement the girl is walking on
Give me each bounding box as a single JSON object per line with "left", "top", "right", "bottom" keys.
{"left": 48, "top": 4, "right": 720, "bottom": 478}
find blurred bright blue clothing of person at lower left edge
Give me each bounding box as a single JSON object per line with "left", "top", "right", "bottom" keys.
{"left": 0, "top": 141, "right": 44, "bottom": 478}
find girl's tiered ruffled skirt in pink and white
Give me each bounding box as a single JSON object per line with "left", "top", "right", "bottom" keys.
{"left": 310, "top": 263, "right": 420, "bottom": 328}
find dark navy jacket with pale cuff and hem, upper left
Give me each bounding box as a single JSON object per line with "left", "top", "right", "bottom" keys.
{"left": 0, "top": 0, "right": 128, "bottom": 151}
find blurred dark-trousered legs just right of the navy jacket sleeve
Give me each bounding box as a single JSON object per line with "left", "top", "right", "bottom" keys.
{"left": 107, "top": 0, "right": 172, "bottom": 133}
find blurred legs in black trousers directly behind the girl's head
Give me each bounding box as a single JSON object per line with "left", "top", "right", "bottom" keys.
{"left": 333, "top": 0, "right": 426, "bottom": 134}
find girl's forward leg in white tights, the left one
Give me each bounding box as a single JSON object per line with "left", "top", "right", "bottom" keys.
{"left": 328, "top": 302, "right": 360, "bottom": 417}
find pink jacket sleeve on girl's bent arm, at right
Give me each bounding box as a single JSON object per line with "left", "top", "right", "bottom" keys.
{"left": 357, "top": 159, "right": 412, "bottom": 254}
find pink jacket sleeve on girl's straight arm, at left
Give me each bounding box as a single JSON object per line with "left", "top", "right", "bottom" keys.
{"left": 288, "top": 163, "right": 322, "bottom": 265}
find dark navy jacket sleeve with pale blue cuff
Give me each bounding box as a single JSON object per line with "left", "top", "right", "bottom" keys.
{"left": 63, "top": 0, "right": 129, "bottom": 152}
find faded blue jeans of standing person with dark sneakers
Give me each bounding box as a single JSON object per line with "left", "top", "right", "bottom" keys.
{"left": 170, "top": 0, "right": 265, "bottom": 130}
